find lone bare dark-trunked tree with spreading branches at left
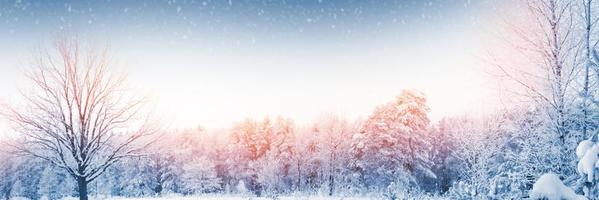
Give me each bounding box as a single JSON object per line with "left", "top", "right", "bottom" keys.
{"left": 2, "top": 37, "right": 156, "bottom": 200}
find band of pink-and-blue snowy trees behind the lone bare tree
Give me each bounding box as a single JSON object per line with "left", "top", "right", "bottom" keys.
{"left": 0, "top": 90, "right": 574, "bottom": 199}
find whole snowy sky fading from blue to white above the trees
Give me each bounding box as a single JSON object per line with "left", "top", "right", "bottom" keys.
{"left": 0, "top": 0, "right": 506, "bottom": 128}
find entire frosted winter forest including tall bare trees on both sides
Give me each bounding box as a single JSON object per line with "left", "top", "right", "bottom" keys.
{"left": 0, "top": 0, "right": 599, "bottom": 200}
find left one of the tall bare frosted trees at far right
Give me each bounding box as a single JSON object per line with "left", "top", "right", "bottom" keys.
{"left": 494, "top": 0, "right": 581, "bottom": 172}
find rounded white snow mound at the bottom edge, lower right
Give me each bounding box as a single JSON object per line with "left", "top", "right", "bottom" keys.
{"left": 530, "top": 173, "right": 587, "bottom": 200}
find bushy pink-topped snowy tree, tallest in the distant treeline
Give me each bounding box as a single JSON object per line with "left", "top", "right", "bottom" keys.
{"left": 352, "top": 90, "right": 434, "bottom": 190}
